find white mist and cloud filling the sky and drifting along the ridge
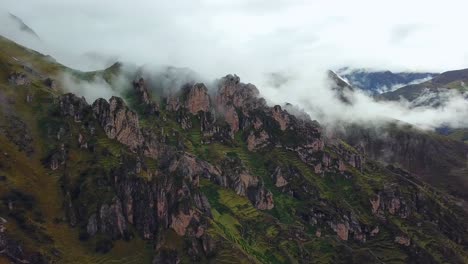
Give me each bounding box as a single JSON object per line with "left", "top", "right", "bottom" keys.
{"left": 0, "top": 0, "right": 468, "bottom": 129}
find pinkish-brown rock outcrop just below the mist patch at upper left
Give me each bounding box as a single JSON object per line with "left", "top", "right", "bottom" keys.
{"left": 93, "top": 96, "right": 143, "bottom": 150}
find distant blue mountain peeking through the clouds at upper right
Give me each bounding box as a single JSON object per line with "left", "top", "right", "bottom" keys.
{"left": 337, "top": 68, "right": 438, "bottom": 93}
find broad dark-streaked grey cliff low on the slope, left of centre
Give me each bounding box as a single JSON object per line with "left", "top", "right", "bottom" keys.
{"left": 106, "top": 151, "right": 220, "bottom": 239}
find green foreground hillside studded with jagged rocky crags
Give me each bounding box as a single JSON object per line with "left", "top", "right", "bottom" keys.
{"left": 0, "top": 35, "right": 468, "bottom": 263}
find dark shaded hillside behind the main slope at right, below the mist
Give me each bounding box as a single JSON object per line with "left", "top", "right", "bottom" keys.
{"left": 343, "top": 122, "right": 468, "bottom": 201}
